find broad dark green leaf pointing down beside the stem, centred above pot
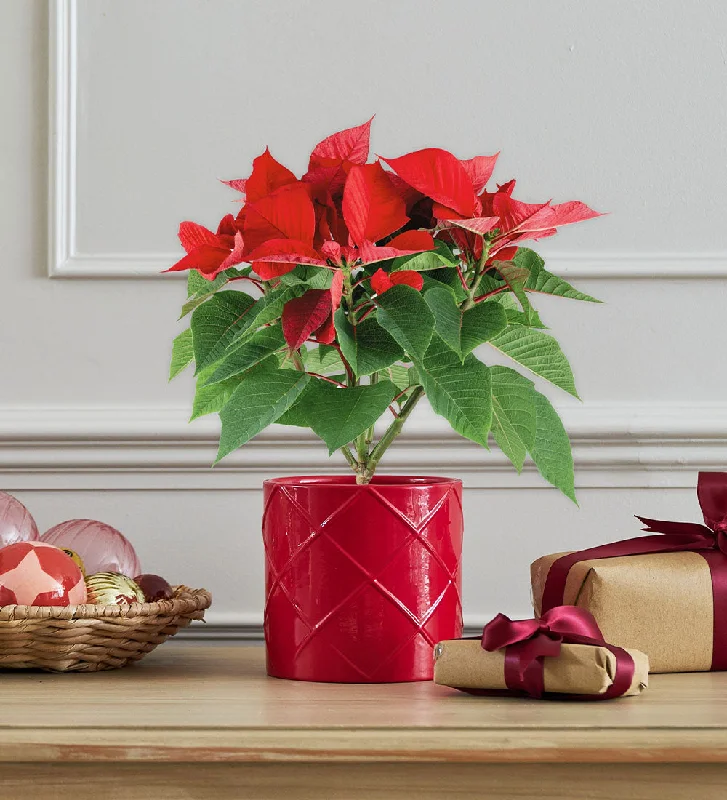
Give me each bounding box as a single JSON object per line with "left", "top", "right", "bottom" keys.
{"left": 305, "top": 379, "right": 398, "bottom": 453}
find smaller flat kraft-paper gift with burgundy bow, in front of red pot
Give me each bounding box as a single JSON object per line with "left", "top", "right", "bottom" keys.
{"left": 434, "top": 606, "right": 649, "bottom": 700}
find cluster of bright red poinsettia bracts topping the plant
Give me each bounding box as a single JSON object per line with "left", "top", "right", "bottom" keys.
{"left": 169, "top": 120, "right": 599, "bottom": 349}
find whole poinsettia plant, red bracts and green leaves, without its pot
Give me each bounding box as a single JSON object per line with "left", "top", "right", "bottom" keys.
{"left": 168, "top": 120, "right": 598, "bottom": 499}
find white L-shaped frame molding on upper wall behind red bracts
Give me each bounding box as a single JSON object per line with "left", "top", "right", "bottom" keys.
{"left": 48, "top": 0, "right": 727, "bottom": 280}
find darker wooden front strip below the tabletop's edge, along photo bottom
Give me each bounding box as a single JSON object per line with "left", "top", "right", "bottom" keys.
{"left": 0, "top": 763, "right": 727, "bottom": 800}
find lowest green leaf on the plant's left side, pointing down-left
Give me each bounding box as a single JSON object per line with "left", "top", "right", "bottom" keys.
{"left": 215, "top": 362, "right": 311, "bottom": 463}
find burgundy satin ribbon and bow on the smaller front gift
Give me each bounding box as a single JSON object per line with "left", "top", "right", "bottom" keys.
{"left": 482, "top": 606, "right": 634, "bottom": 700}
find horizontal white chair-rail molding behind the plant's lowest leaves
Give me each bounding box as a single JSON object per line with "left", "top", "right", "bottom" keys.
{"left": 0, "top": 403, "right": 727, "bottom": 491}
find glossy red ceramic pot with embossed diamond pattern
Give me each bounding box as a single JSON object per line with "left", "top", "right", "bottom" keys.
{"left": 263, "top": 475, "right": 462, "bottom": 683}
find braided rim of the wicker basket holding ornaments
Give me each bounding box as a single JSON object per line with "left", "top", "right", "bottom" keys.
{"left": 0, "top": 585, "right": 212, "bottom": 623}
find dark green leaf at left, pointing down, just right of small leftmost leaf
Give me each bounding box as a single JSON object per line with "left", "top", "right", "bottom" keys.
{"left": 190, "top": 291, "right": 260, "bottom": 373}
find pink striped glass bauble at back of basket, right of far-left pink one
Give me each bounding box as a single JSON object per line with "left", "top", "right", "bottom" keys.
{"left": 40, "top": 519, "right": 141, "bottom": 578}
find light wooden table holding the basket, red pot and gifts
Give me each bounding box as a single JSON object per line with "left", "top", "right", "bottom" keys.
{"left": 0, "top": 645, "right": 727, "bottom": 800}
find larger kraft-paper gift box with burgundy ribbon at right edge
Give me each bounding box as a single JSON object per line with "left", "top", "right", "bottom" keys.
{"left": 531, "top": 472, "right": 727, "bottom": 672}
